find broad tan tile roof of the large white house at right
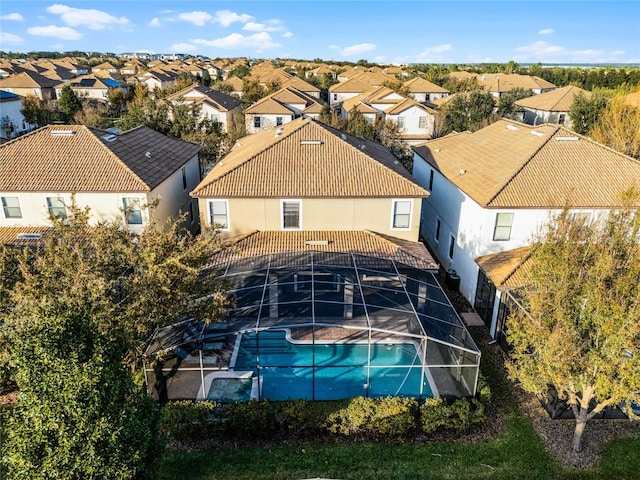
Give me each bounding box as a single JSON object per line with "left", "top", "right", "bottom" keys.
{"left": 413, "top": 119, "right": 640, "bottom": 208}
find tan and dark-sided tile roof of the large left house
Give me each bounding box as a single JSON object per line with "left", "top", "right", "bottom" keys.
{"left": 0, "top": 125, "right": 201, "bottom": 192}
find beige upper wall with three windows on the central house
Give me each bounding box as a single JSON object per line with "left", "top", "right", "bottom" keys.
{"left": 198, "top": 198, "right": 421, "bottom": 241}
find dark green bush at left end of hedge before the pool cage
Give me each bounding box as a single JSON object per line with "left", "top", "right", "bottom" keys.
{"left": 160, "top": 400, "right": 216, "bottom": 441}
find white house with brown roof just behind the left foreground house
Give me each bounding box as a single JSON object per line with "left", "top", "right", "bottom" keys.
{"left": 167, "top": 85, "right": 242, "bottom": 132}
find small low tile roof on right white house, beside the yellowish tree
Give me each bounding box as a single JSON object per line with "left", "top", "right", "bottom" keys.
{"left": 476, "top": 246, "right": 532, "bottom": 290}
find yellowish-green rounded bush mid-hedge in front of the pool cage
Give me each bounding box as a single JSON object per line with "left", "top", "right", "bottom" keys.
{"left": 326, "top": 397, "right": 418, "bottom": 438}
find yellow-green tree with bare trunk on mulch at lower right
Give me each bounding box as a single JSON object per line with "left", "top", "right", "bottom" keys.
{"left": 507, "top": 200, "right": 640, "bottom": 452}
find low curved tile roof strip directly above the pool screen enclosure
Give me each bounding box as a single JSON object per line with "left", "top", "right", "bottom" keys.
{"left": 213, "top": 230, "right": 438, "bottom": 270}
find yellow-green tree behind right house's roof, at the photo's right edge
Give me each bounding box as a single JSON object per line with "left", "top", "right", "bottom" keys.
{"left": 589, "top": 97, "right": 640, "bottom": 160}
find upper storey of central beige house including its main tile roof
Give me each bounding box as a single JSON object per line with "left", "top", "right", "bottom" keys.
{"left": 191, "top": 115, "right": 429, "bottom": 246}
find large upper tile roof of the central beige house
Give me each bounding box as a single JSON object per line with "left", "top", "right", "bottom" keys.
{"left": 192, "top": 119, "right": 429, "bottom": 198}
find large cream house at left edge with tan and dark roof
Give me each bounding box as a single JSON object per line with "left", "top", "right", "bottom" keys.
{"left": 0, "top": 125, "right": 201, "bottom": 232}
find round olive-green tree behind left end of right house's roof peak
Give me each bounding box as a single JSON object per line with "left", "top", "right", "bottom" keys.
{"left": 445, "top": 91, "right": 494, "bottom": 132}
